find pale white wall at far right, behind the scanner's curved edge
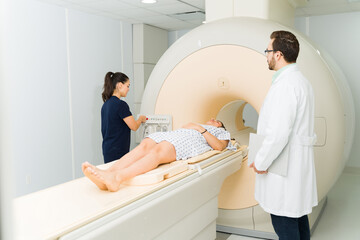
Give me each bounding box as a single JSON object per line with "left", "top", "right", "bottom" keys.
{"left": 295, "top": 12, "right": 360, "bottom": 168}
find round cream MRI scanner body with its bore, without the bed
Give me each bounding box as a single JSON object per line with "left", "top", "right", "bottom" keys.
{"left": 141, "top": 17, "right": 355, "bottom": 238}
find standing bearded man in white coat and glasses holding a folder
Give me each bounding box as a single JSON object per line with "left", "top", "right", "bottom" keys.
{"left": 250, "top": 31, "right": 318, "bottom": 240}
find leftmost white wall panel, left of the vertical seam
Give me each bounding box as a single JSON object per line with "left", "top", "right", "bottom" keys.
{"left": 2, "top": 1, "right": 72, "bottom": 195}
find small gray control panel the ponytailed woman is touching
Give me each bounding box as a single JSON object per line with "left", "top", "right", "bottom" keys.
{"left": 136, "top": 115, "right": 172, "bottom": 143}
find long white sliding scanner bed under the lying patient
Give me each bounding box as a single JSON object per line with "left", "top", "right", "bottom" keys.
{"left": 14, "top": 145, "right": 246, "bottom": 240}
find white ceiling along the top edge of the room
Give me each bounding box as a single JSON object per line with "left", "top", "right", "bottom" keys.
{"left": 41, "top": 0, "right": 360, "bottom": 31}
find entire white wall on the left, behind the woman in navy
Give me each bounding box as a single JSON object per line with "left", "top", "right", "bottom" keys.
{"left": 2, "top": 0, "right": 133, "bottom": 196}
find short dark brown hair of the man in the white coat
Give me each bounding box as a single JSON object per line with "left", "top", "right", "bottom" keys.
{"left": 270, "top": 31, "right": 300, "bottom": 63}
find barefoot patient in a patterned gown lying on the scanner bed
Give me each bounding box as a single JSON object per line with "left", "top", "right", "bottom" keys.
{"left": 82, "top": 119, "right": 233, "bottom": 192}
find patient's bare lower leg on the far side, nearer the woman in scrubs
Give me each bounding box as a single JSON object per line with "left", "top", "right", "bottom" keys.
{"left": 109, "top": 138, "right": 156, "bottom": 172}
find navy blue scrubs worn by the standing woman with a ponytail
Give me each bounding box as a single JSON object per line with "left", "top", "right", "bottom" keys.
{"left": 101, "top": 96, "right": 132, "bottom": 163}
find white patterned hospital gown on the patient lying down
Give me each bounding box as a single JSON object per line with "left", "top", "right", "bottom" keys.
{"left": 148, "top": 125, "right": 236, "bottom": 160}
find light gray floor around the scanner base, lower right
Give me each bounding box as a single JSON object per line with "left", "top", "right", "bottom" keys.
{"left": 216, "top": 172, "right": 360, "bottom": 240}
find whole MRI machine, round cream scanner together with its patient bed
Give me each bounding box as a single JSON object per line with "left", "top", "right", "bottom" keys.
{"left": 14, "top": 17, "right": 355, "bottom": 239}
